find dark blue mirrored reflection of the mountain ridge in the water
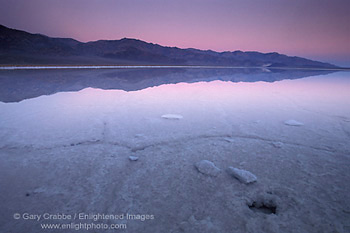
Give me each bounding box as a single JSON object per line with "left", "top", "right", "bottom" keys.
{"left": 0, "top": 68, "right": 333, "bottom": 102}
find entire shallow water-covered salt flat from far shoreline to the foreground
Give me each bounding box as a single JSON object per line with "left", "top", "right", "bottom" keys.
{"left": 0, "top": 69, "right": 350, "bottom": 232}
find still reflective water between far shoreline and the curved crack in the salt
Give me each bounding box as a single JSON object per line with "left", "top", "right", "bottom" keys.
{"left": 0, "top": 69, "right": 350, "bottom": 148}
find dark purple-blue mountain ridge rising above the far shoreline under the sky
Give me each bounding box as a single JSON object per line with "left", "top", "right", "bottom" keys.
{"left": 0, "top": 25, "right": 337, "bottom": 68}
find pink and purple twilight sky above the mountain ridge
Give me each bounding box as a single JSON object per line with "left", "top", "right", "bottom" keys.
{"left": 0, "top": 0, "right": 350, "bottom": 67}
